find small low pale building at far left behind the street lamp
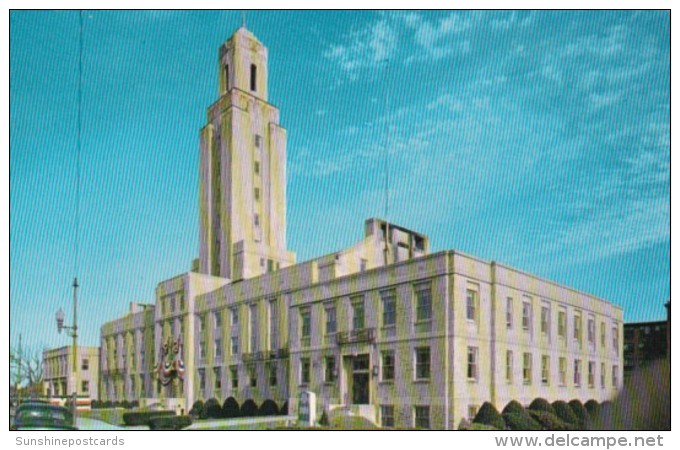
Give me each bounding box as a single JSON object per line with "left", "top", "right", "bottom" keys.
{"left": 42, "top": 345, "right": 99, "bottom": 403}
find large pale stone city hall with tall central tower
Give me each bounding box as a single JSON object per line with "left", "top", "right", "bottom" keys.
{"left": 100, "top": 27, "right": 623, "bottom": 429}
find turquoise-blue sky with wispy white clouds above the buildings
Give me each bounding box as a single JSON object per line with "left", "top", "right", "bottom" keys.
{"left": 10, "top": 11, "right": 670, "bottom": 349}
